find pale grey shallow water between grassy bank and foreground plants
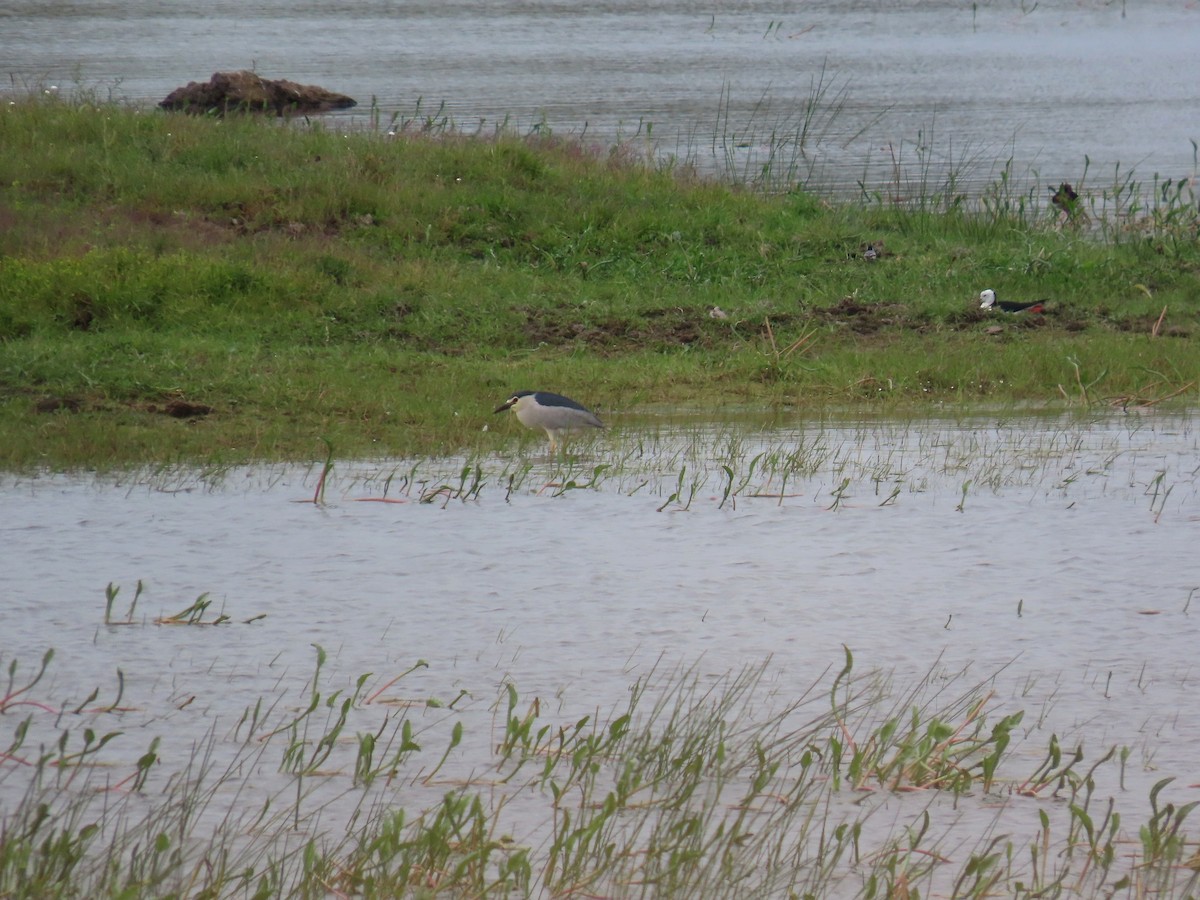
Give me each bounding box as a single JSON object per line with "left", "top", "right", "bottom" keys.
{"left": 0, "top": 414, "right": 1200, "bottom": 897}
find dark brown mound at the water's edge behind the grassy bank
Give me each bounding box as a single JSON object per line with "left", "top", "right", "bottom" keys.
{"left": 158, "top": 72, "right": 358, "bottom": 115}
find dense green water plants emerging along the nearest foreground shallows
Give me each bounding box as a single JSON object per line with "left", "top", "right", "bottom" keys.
{"left": 0, "top": 643, "right": 1200, "bottom": 900}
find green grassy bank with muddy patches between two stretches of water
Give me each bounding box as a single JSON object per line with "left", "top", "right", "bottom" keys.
{"left": 0, "top": 97, "right": 1200, "bottom": 468}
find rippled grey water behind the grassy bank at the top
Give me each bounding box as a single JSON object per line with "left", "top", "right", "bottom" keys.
{"left": 0, "top": 0, "right": 1200, "bottom": 196}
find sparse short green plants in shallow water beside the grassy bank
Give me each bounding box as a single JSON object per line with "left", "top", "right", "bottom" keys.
{"left": 292, "top": 414, "right": 1194, "bottom": 521}
